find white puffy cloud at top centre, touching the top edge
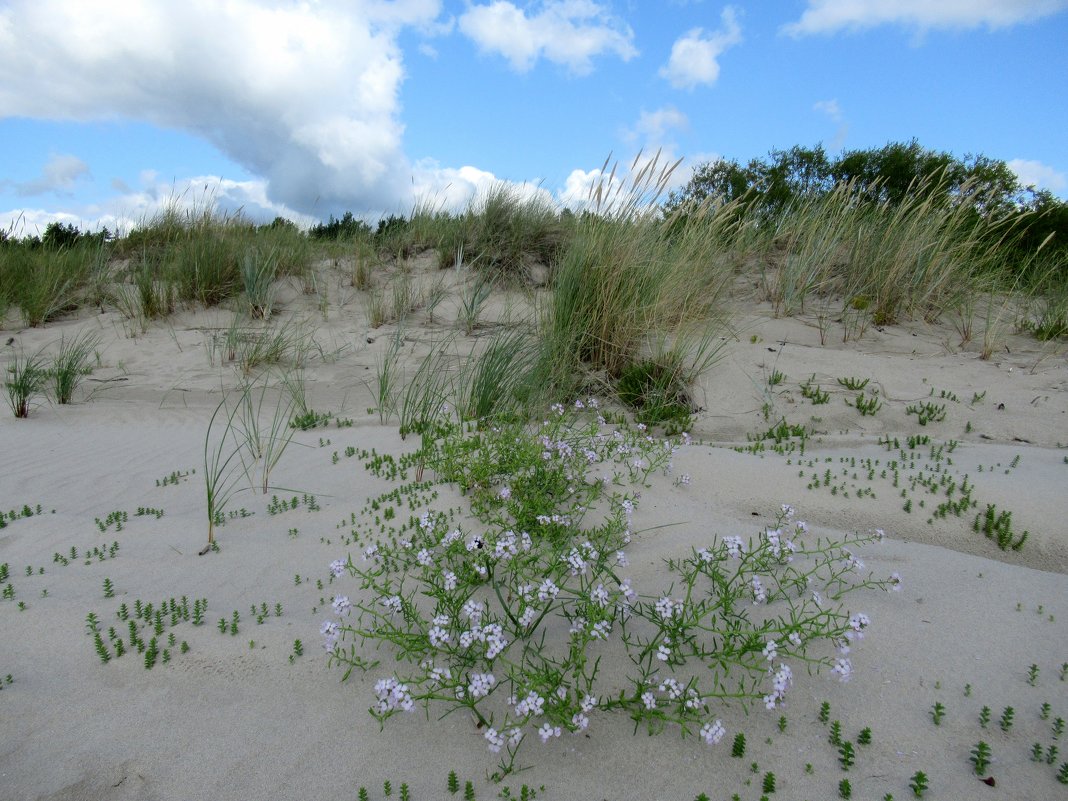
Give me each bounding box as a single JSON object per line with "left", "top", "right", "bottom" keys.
{"left": 458, "top": 0, "right": 638, "bottom": 75}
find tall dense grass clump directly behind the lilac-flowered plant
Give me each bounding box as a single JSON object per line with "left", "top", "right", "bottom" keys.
{"left": 543, "top": 151, "right": 732, "bottom": 394}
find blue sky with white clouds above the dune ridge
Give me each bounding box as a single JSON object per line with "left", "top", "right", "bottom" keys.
{"left": 0, "top": 0, "right": 1068, "bottom": 236}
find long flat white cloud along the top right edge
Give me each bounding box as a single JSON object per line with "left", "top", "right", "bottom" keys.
{"left": 783, "top": 0, "right": 1068, "bottom": 36}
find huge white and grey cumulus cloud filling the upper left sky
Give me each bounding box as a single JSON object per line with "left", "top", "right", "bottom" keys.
{"left": 0, "top": 0, "right": 441, "bottom": 217}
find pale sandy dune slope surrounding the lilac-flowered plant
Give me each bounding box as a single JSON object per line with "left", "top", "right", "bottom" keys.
{"left": 0, "top": 264, "right": 1068, "bottom": 801}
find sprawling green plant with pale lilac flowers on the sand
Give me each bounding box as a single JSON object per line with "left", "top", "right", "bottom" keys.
{"left": 321, "top": 401, "right": 899, "bottom": 776}
